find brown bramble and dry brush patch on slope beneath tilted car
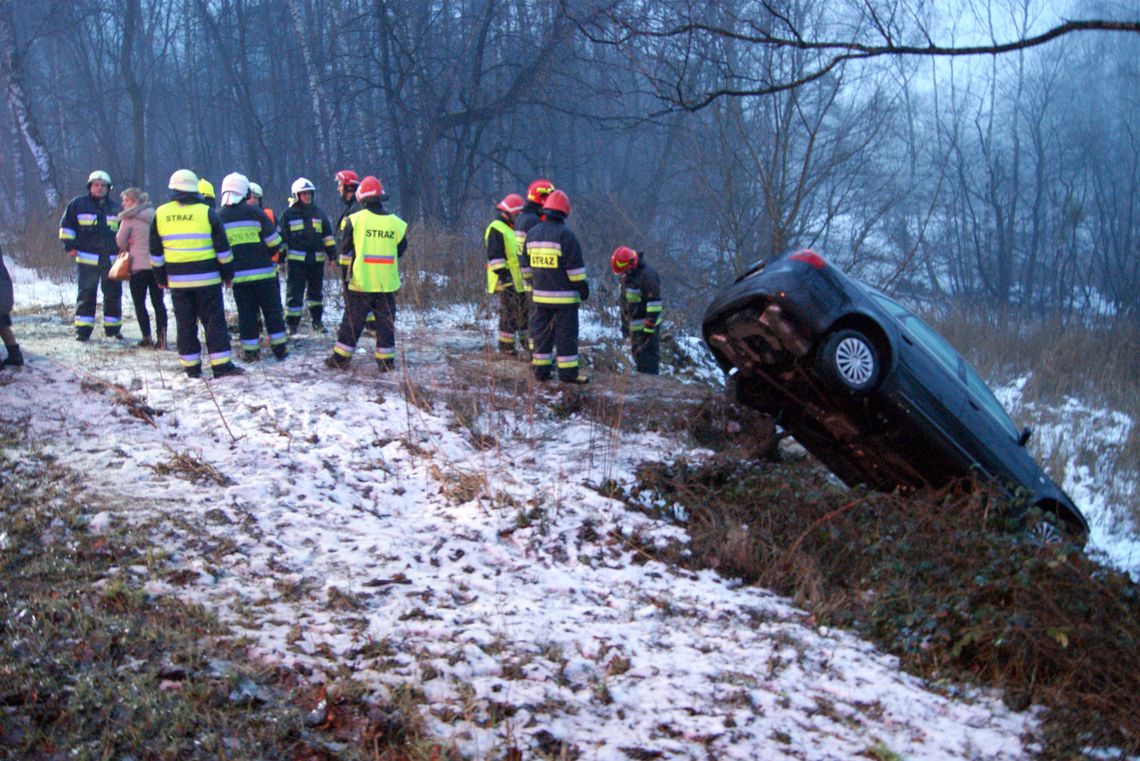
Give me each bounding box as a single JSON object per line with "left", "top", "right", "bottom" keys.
{"left": 630, "top": 458, "right": 1140, "bottom": 759}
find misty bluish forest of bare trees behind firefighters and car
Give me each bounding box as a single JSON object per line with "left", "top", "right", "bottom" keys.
{"left": 0, "top": 0, "right": 1140, "bottom": 335}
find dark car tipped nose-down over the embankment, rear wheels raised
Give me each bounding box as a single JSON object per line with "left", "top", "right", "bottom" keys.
{"left": 703, "top": 251, "right": 1089, "bottom": 540}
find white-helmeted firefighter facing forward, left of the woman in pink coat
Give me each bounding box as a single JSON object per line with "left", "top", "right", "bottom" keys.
{"left": 59, "top": 170, "right": 123, "bottom": 342}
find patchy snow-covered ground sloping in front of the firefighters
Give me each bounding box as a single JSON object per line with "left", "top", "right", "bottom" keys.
{"left": 0, "top": 262, "right": 1134, "bottom": 760}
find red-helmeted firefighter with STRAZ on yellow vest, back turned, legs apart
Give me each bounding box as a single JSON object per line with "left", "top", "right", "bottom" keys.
{"left": 325, "top": 177, "right": 408, "bottom": 373}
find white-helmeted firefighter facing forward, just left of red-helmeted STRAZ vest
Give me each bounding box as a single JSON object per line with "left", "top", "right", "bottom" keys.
{"left": 278, "top": 177, "right": 336, "bottom": 335}
